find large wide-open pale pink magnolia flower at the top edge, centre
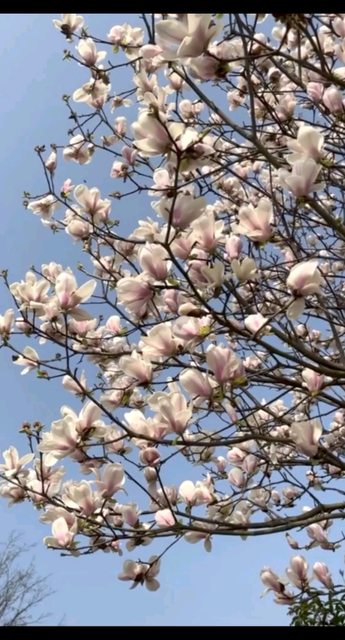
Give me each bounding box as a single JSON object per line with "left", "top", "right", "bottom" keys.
{"left": 156, "top": 13, "right": 222, "bottom": 60}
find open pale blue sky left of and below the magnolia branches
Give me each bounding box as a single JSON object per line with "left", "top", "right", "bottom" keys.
{"left": 0, "top": 14, "right": 339, "bottom": 626}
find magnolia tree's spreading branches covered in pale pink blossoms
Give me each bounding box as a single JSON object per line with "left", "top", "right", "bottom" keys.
{"left": 0, "top": 14, "right": 345, "bottom": 605}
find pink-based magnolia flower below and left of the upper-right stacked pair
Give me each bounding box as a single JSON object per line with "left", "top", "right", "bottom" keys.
{"left": 231, "top": 198, "right": 273, "bottom": 242}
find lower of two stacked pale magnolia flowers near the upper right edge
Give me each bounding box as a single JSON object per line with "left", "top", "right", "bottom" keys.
{"left": 278, "top": 158, "right": 324, "bottom": 198}
